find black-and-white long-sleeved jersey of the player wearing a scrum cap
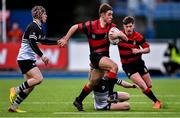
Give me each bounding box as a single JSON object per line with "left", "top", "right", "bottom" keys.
{"left": 17, "top": 21, "right": 57, "bottom": 60}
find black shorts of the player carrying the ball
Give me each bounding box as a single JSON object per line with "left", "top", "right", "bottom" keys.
{"left": 90, "top": 52, "right": 109, "bottom": 69}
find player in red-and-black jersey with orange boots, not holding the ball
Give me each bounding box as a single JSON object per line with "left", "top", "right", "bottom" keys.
{"left": 118, "top": 16, "right": 161, "bottom": 109}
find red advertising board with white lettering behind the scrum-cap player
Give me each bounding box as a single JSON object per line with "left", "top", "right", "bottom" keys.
{"left": 0, "top": 43, "right": 68, "bottom": 69}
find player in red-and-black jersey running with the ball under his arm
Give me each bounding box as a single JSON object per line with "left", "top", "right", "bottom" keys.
{"left": 58, "top": 3, "right": 127, "bottom": 111}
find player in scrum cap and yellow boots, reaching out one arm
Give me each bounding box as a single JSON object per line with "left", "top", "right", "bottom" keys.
{"left": 8, "top": 6, "right": 57, "bottom": 112}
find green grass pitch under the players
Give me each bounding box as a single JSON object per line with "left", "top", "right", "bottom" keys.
{"left": 0, "top": 79, "right": 180, "bottom": 118}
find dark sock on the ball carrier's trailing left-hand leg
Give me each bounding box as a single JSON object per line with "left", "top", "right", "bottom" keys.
{"left": 78, "top": 85, "right": 92, "bottom": 102}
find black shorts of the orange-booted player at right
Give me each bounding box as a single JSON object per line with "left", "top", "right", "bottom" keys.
{"left": 122, "top": 59, "right": 149, "bottom": 78}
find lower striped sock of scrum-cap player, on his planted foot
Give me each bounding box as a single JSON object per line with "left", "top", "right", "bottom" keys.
{"left": 12, "top": 91, "right": 28, "bottom": 109}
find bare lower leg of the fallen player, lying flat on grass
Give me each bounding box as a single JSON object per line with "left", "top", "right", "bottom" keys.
{"left": 110, "top": 102, "right": 131, "bottom": 110}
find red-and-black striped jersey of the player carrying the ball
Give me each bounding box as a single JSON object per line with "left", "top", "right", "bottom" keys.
{"left": 78, "top": 19, "right": 116, "bottom": 56}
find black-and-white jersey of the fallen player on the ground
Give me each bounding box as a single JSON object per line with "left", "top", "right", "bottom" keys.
{"left": 93, "top": 79, "right": 109, "bottom": 109}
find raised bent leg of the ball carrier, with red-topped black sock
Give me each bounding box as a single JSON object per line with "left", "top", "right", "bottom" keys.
{"left": 99, "top": 57, "right": 118, "bottom": 95}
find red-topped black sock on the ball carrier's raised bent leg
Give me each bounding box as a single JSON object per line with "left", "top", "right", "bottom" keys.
{"left": 106, "top": 72, "right": 117, "bottom": 95}
